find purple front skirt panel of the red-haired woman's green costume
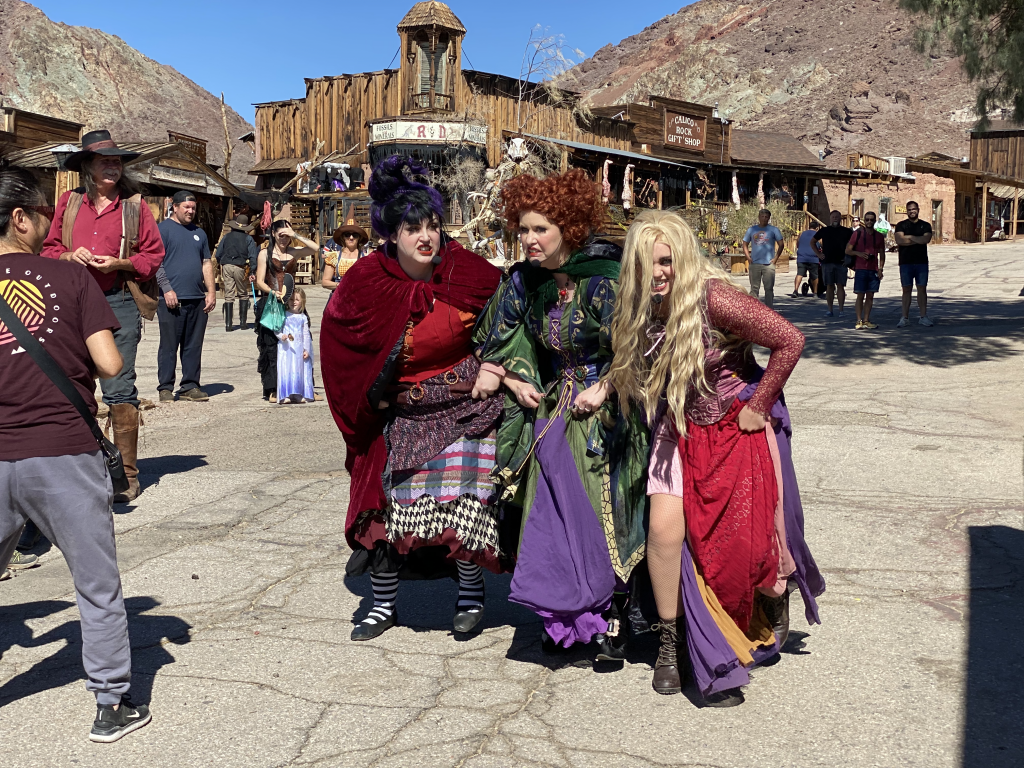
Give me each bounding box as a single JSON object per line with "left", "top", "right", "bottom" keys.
{"left": 509, "top": 415, "right": 616, "bottom": 647}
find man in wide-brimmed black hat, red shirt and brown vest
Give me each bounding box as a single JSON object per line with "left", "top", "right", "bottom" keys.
{"left": 41, "top": 131, "right": 164, "bottom": 502}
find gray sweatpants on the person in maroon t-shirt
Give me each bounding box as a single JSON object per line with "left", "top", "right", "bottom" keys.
{"left": 0, "top": 451, "right": 131, "bottom": 705}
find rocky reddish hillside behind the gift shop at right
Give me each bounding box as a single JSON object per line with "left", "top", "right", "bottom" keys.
{"left": 573, "top": 0, "right": 976, "bottom": 167}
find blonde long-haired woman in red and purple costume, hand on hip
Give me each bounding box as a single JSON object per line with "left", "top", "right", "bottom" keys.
{"left": 607, "top": 211, "right": 824, "bottom": 707}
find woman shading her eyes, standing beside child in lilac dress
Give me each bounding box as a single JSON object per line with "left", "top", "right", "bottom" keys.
{"left": 255, "top": 219, "right": 319, "bottom": 402}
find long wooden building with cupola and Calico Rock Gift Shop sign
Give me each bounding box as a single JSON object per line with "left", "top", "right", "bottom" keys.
{"left": 250, "top": 0, "right": 905, "bottom": 270}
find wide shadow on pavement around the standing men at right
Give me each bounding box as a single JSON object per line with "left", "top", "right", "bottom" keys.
{"left": 775, "top": 294, "right": 1024, "bottom": 368}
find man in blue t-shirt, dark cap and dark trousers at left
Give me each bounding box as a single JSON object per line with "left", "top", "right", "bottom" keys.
{"left": 157, "top": 191, "right": 217, "bottom": 402}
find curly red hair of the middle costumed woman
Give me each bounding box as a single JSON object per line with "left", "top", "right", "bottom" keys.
{"left": 502, "top": 168, "right": 604, "bottom": 250}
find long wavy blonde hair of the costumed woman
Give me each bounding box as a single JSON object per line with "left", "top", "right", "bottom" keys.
{"left": 607, "top": 211, "right": 744, "bottom": 433}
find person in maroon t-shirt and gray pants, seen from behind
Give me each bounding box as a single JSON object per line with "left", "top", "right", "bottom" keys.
{"left": 0, "top": 169, "right": 150, "bottom": 742}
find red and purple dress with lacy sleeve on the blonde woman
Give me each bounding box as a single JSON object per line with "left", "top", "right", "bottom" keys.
{"left": 648, "top": 280, "right": 824, "bottom": 695}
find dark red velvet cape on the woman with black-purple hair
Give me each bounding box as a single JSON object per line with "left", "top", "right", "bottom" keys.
{"left": 321, "top": 241, "right": 502, "bottom": 545}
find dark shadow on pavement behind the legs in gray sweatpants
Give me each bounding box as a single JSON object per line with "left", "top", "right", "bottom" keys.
{"left": 0, "top": 597, "right": 191, "bottom": 707}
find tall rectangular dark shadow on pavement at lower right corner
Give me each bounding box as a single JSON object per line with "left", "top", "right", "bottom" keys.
{"left": 963, "top": 525, "right": 1024, "bottom": 768}
